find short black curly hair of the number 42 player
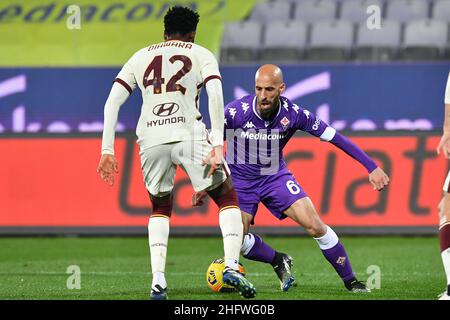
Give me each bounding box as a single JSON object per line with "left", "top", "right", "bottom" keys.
{"left": 164, "top": 6, "right": 200, "bottom": 36}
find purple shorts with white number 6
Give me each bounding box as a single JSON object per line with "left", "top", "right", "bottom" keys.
{"left": 231, "top": 169, "right": 307, "bottom": 220}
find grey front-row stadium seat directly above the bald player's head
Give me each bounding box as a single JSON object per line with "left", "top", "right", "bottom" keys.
{"left": 261, "top": 21, "right": 307, "bottom": 63}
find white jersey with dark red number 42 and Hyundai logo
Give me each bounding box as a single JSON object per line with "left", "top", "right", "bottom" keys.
{"left": 115, "top": 40, "right": 220, "bottom": 150}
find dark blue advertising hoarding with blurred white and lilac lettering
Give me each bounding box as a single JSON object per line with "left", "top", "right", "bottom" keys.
{"left": 0, "top": 63, "right": 448, "bottom": 133}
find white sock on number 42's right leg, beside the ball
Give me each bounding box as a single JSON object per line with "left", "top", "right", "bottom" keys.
{"left": 219, "top": 207, "right": 244, "bottom": 270}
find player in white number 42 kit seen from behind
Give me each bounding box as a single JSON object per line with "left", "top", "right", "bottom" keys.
{"left": 97, "top": 6, "right": 256, "bottom": 300}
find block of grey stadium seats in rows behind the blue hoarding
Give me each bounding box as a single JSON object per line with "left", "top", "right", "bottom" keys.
{"left": 222, "top": 0, "right": 450, "bottom": 63}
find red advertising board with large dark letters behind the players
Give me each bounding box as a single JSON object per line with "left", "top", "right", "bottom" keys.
{"left": 0, "top": 133, "right": 448, "bottom": 234}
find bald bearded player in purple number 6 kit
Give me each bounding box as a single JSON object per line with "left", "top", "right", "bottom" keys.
{"left": 193, "top": 64, "right": 389, "bottom": 292}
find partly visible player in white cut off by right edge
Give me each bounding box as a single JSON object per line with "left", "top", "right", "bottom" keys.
{"left": 437, "top": 72, "right": 450, "bottom": 300}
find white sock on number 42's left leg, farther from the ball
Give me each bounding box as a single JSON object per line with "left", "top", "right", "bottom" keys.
{"left": 148, "top": 216, "right": 170, "bottom": 289}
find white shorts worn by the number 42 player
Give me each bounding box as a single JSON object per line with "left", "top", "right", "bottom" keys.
{"left": 140, "top": 140, "right": 227, "bottom": 196}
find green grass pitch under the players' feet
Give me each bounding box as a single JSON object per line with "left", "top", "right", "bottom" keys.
{"left": 0, "top": 237, "right": 445, "bottom": 300}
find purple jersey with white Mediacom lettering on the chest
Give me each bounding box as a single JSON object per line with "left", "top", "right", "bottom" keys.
{"left": 225, "top": 95, "right": 336, "bottom": 180}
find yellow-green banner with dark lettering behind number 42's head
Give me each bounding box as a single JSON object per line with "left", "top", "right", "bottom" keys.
{"left": 0, "top": 0, "right": 258, "bottom": 66}
